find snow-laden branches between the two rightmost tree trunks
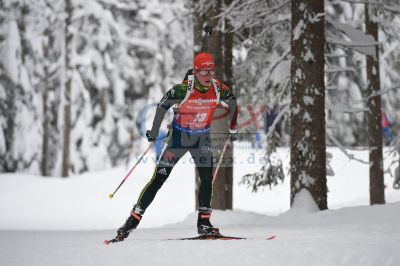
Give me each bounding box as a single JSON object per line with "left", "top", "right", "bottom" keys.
{"left": 325, "top": 2, "right": 373, "bottom": 146}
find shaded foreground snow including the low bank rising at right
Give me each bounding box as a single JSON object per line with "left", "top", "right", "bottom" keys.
{"left": 0, "top": 203, "right": 400, "bottom": 266}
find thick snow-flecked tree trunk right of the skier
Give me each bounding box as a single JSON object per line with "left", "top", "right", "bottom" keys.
{"left": 290, "top": 0, "right": 328, "bottom": 210}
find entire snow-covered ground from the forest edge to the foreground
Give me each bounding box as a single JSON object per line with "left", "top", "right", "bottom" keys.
{"left": 0, "top": 144, "right": 400, "bottom": 265}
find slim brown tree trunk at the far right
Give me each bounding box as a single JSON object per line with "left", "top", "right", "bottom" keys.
{"left": 365, "top": 4, "right": 385, "bottom": 205}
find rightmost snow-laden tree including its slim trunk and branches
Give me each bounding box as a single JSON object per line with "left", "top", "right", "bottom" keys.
{"left": 327, "top": 1, "right": 399, "bottom": 203}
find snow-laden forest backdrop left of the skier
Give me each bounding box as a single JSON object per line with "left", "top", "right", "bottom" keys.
{"left": 0, "top": 0, "right": 192, "bottom": 175}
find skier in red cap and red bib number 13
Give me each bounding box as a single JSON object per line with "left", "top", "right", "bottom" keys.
{"left": 112, "top": 53, "right": 237, "bottom": 241}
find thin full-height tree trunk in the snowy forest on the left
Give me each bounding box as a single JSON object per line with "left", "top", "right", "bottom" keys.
{"left": 61, "top": 0, "right": 72, "bottom": 177}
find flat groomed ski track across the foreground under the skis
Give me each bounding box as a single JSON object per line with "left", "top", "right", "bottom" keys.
{"left": 0, "top": 228, "right": 400, "bottom": 266}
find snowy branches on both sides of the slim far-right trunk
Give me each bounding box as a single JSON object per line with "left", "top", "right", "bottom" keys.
{"left": 325, "top": 1, "right": 399, "bottom": 149}
